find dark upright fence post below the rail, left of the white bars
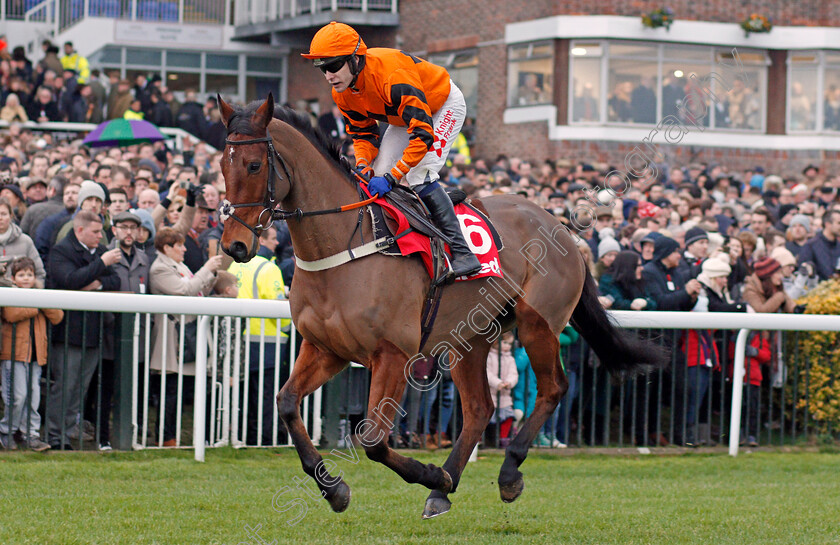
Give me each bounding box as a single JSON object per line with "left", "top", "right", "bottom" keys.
{"left": 111, "top": 313, "right": 137, "bottom": 450}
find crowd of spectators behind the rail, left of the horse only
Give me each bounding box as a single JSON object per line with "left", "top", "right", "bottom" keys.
{"left": 0, "top": 116, "right": 294, "bottom": 450}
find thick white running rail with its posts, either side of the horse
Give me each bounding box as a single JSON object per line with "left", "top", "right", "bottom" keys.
{"left": 0, "top": 288, "right": 840, "bottom": 461}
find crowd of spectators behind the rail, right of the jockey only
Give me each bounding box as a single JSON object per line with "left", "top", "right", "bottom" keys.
{"left": 430, "top": 152, "right": 840, "bottom": 445}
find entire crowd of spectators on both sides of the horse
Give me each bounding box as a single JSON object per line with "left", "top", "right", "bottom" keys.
{"left": 0, "top": 66, "right": 840, "bottom": 448}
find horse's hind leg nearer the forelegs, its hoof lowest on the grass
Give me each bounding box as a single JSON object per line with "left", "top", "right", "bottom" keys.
{"left": 423, "top": 338, "right": 493, "bottom": 518}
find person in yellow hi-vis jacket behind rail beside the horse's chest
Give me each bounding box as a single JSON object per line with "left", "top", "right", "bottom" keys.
{"left": 228, "top": 226, "right": 290, "bottom": 445}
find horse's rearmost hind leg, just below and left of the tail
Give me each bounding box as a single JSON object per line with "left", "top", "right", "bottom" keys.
{"left": 499, "top": 301, "right": 569, "bottom": 503}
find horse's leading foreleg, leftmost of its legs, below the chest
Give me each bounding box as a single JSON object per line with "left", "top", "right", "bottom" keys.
{"left": 277, "top": 340, "right": 350, "bottom": 513}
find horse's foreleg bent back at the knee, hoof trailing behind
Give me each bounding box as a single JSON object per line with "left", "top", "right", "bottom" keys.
{"left": 357, "top": 341, "right": 452, "bottom": 500}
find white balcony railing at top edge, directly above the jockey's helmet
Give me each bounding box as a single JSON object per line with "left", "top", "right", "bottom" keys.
{"left": 234, "top": 0, "right": 397, "bottom": 26}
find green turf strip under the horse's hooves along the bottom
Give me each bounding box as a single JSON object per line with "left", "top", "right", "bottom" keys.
{"left": 0, "top": 449, "right": 840, "bottom": 545}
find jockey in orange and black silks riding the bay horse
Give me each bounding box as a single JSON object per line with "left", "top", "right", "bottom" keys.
{"left": 303, "top": 22, "right": 481, "bottom": 277}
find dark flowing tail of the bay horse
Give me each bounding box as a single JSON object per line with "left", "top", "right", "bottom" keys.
{"left": 571, "top": 268, "right": 669, "bottom": 373}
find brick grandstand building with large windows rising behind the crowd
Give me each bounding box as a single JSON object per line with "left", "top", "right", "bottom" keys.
{"left": 5, "top": 0, "right": 840, "bottom": 174}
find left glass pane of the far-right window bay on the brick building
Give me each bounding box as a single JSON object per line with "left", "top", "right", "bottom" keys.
{"left": 787, "top": 53, "right": 819, "bottom": 131}
